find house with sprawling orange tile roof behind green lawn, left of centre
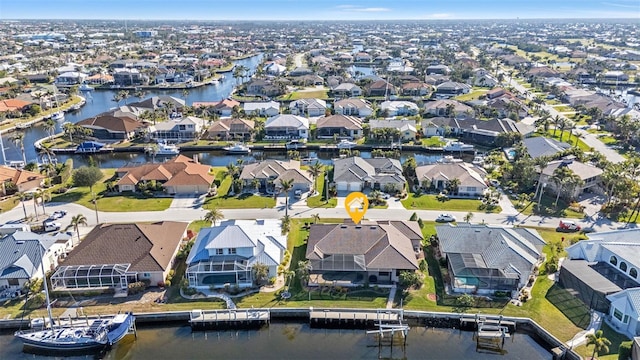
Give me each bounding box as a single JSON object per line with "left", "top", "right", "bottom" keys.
{"left": 115, "top": 155, "right": 215, "bottom": 194}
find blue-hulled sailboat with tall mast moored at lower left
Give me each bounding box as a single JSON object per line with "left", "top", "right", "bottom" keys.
{"left": 14, "top": 246, "right": 135, "bottom": 351}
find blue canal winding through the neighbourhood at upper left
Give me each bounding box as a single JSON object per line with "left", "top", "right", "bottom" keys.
{"left": 0, "top": 55, "right": 262, "bottom": 164}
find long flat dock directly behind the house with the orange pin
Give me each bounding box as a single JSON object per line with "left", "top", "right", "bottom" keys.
{"left": 309, "top": 309, "right": 403, "bottom": 329}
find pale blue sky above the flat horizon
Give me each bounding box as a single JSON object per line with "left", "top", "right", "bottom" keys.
{"left": 0, "top": 0, "right": 640, "bottom": 20}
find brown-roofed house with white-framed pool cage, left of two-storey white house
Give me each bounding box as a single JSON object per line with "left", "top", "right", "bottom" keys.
{"left": 51, "top": 221, "right": 189, "bottom": 292}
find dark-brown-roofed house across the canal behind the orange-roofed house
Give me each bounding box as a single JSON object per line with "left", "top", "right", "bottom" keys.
{"left": 77, "top": 113, "right": 147, "bottom": 141}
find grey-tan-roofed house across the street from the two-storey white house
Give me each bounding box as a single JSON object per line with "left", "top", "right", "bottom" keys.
{"left": 240, "top": 160, "right": 312, "bottom": 193}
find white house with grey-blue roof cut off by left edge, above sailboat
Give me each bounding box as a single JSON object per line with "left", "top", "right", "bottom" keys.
{"left": 0, "top": 231, "right": 73, "bottom": 290}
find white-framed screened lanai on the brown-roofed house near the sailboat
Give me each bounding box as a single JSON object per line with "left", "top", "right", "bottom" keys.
{"left": 51, "top": 264, "right": 131, "bottom": 290}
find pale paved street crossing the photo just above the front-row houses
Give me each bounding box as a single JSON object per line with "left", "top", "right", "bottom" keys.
{"left": 5, "top": 197, "right": 634, "bottom": 233}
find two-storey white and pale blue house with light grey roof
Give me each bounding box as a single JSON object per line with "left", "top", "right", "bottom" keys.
{"left": 186, "top": 219, "right": 287, "bottom": 290}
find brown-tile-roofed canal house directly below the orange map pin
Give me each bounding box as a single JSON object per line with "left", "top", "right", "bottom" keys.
{"left": 306, "top": 221, "right": 422, "bottom": 286}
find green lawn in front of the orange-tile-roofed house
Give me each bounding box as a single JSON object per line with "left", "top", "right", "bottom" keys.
{"left": 51, "top": 169, "right": 172, "bottom": 212}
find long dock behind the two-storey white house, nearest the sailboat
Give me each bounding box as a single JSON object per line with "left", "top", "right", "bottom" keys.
{"left": 189, "top": 309, "right": 271, "bottom": 329}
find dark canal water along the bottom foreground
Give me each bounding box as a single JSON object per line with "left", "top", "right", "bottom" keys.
{"left": 0, "top": 323, "right": 551, "bottom": 360}
